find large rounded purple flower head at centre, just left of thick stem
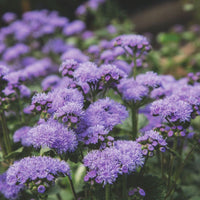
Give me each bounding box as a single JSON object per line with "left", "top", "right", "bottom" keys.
{"left": 81, "top": 98, "right": 128, "bottom": 130}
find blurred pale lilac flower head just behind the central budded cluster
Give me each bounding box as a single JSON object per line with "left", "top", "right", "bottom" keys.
{"left": 61, "top": 48, "right": 89, "bottom": 62}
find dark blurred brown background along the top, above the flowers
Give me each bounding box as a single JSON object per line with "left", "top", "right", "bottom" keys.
{"left": 0, "top": 0, "right": 200, "bottom": 32}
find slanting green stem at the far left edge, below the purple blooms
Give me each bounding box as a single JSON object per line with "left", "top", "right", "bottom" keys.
{"left": 0, "top": 111, "right": 11, "bottom": 154}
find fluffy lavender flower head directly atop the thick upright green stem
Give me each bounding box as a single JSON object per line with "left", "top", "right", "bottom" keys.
{"left": 118, "top": 78, "right": 149, "bottom": 102}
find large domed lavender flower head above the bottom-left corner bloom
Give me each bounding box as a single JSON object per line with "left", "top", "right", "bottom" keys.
{"left": 25, "top": 120, "right": 78, "bottom": 154}
